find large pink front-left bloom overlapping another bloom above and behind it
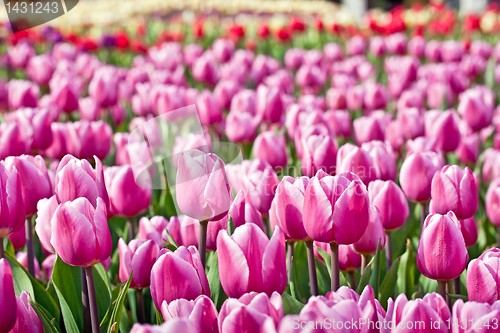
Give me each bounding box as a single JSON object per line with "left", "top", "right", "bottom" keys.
{"left": 50, "top": 198, "right": 112, "bottom": 267}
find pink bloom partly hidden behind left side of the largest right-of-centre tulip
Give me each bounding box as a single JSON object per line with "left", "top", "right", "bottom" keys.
{"left": 273, "top": 176, "right": 309, "bottom": 240}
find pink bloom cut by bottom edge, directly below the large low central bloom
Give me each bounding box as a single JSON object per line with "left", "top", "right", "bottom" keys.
{"left": 218, "top": 292, "right": 283, "bottom": 333}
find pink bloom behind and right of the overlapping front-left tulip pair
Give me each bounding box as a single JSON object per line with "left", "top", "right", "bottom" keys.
{"left": 104, "top": 165, "right": 152, "bottom": 217}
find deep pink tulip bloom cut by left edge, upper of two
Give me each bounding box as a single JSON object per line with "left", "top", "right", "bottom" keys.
{"left": 0, "top": 165, "right": 26, "bottom": 240}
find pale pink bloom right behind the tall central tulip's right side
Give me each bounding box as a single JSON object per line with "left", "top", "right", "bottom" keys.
{"left": 226, "top": 159, "right": 279, "bottom": 214}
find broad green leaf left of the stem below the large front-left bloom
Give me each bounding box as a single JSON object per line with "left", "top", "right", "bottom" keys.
{"left": 52, "top": 256, "right": 83, "bottom": 333}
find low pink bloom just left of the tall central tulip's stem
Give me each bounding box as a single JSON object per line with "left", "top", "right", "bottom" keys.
{"left": 151, "top": 246, "right": 210, "bottom": 311}
